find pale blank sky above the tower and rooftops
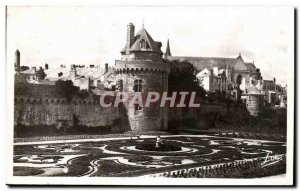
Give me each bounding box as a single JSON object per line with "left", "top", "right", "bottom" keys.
{"left": 7, "top": 6, "right": 294, "bottom": 85}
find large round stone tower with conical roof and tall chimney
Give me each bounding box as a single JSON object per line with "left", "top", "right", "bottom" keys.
{"left": 115, "top": 23, "right": 170, "bottom": 131}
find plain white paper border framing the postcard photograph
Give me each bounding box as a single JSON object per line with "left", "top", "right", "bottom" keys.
{"left": 5, "top": 4, "right": 295, "bottom": 186}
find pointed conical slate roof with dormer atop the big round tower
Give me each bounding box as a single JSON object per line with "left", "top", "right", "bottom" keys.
{"left": 121, "top": 28, "right": 162, "bottom": 54}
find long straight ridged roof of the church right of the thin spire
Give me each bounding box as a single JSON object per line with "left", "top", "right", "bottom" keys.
{"left": 168, "top": 56, "right": 237, "bottom": 71}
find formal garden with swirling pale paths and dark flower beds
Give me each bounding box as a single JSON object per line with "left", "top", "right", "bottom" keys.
{"left": 14, "top": 135, "right": 286, "bottom": 178}
